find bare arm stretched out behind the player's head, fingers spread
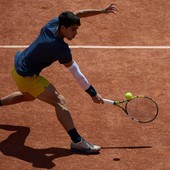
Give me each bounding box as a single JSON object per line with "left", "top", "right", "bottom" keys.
{"left": 74, "top": 3, "right": 118, "bottom": 18}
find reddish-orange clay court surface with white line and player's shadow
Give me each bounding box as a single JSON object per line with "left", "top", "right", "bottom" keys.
{"left": 0, "top": 0, "right": 170, "bottom": 170}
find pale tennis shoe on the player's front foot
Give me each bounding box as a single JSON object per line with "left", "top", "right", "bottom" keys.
{"left": 71, "top": 138, "right": 101, "bottom": 154}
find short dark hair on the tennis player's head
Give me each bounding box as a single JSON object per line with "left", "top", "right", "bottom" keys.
{"left": 59, "top": 11, "right": 81, "bottom": 29}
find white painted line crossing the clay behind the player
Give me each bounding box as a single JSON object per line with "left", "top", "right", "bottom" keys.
{"left": 0, "top": 45, "right": 170, "bottom": 49}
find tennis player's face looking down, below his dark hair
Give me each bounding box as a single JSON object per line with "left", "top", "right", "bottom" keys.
{"left": 63, "top": 25, "right": 79, "bottom": 40}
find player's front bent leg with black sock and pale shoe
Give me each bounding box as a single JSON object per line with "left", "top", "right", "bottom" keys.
{"left": 37, "top": 84, "right": 101, "bottom": 154}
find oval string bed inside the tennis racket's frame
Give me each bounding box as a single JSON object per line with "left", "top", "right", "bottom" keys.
{"left": 126, "top": 98, "right": 158, "bottom": 122}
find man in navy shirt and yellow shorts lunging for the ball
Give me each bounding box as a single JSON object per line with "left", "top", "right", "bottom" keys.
{"left": 0, "top": 4, "right": 117, "bottom": 153}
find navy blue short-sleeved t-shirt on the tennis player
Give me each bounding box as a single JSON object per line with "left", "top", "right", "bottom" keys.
{"left": 15, "top": 18, "right": 72, "bottom": 76}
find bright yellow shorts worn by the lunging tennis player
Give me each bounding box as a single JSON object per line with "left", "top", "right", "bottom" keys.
{"left": 12, "top": 68, "right": 50, "bottom": 97}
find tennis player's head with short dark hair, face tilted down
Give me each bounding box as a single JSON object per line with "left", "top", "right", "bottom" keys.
{"left": 58, "top": 11, "right": 81, "bottom": 40}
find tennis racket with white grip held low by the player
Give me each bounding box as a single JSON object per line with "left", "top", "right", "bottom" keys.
{"left": 103, "top": 96, "right": 159, "bottom": 123}
